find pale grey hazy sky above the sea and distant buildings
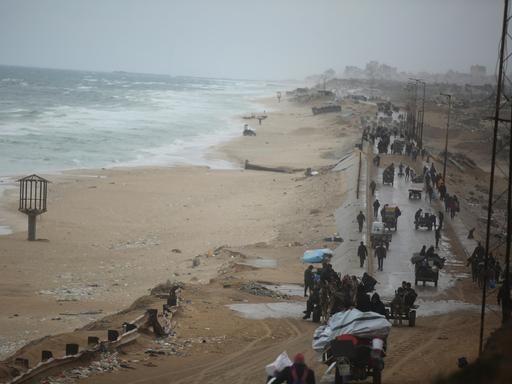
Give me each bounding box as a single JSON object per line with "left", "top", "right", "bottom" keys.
{"left": 0, "top": 0, "right": 503, "bottom": 79}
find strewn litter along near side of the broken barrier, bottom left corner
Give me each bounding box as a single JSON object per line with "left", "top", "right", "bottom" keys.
{"left": 39, "top": 352, "right": 125, "bottom": 384}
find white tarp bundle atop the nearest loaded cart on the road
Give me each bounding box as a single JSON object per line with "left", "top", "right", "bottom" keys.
{"left": 313, "top": 308, "right": 391, "bottom": 352}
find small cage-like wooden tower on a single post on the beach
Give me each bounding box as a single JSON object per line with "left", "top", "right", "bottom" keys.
{"left": 18, "top": 175, "right": 49, "bottom": 241}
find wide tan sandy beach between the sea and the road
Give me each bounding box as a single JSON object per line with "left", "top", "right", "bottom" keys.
{"left": 0, "top": 100, "right": 359, "bottom": 356}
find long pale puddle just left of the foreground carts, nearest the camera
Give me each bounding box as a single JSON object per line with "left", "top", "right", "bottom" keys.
{"left": 228, "top": 302, "right": 306, "bottom": 320}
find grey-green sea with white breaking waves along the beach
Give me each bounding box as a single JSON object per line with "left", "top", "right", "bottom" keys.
{"left": 0, "top": 66, "right": 282, "bottom": 176}
